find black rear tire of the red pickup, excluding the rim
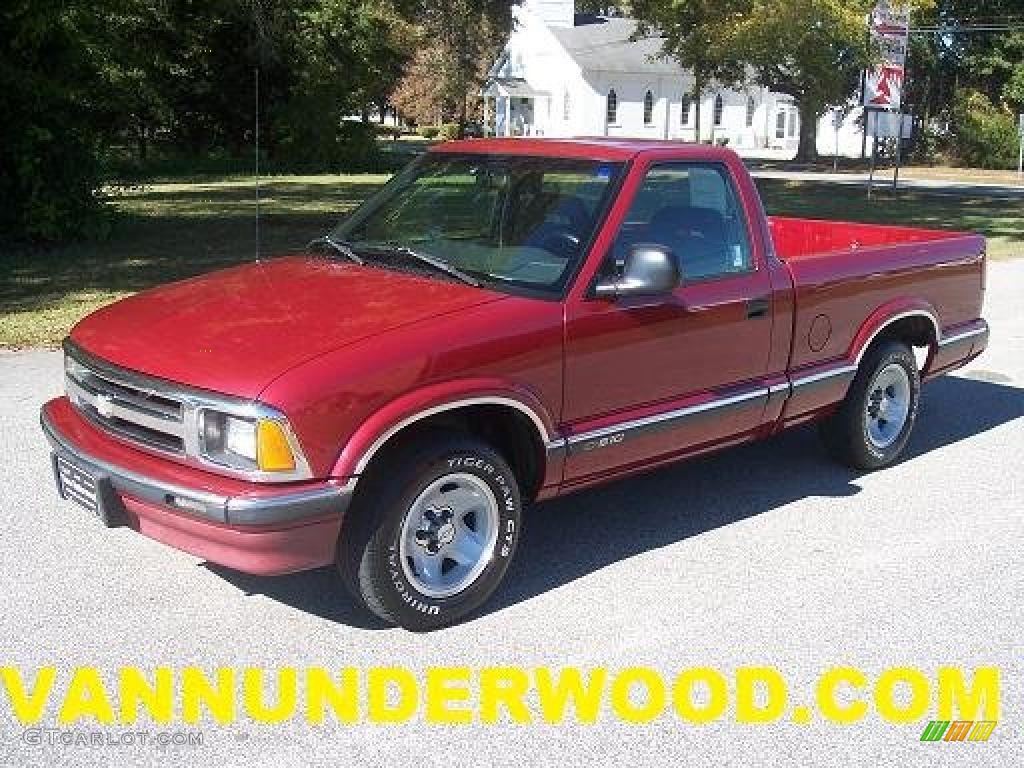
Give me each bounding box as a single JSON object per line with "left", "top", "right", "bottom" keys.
{"left": 819, "top": 341, "right": 921, "bottom": 470}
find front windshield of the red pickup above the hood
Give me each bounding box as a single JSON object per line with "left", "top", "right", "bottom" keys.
{"left": 331, "top": 153, "right": 622, "bottom": 294}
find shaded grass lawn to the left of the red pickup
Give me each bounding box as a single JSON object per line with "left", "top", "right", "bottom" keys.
{"left": 0, "top": 175, "right": 387, "bottom": 347}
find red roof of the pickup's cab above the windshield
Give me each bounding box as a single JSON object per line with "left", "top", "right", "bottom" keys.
{"left": 430, "top": 137, "right": 734, "bottom": 162}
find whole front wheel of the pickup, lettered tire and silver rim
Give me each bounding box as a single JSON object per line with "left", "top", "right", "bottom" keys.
{"left": 338, "top": 432, "right": 522, "bottom": 631}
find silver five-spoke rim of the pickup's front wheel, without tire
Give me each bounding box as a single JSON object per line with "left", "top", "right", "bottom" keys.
{"left": 398, "top": 472, "right": 500, "bottom": 598}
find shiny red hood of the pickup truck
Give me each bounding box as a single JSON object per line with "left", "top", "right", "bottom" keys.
{"left": 72, "top": 256, "right": 504, "bottom": 398}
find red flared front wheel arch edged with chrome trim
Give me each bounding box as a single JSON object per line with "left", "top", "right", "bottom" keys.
{"left": 331, "top": 378, "right": 564, "bottom": 484}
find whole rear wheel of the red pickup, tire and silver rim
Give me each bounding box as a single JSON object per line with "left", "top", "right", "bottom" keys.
{"left": 820, "top": 341, "right": 921, "bottom": 469}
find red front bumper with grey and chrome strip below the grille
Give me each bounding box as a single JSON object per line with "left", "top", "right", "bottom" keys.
{"left": 40, "top": 397, "right": 354, "bottom": 574}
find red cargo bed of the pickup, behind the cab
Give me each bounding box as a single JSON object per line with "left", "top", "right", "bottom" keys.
{"left": 768, "top": 217, "right": 985, "bottom": 418}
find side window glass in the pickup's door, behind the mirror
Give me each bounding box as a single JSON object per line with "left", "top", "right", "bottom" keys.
{"left": 612, "top": 163, "right": 754, "bottom": 283}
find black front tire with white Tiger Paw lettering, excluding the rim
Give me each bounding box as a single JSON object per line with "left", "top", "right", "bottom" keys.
{"left": 337, "top": 431, "right": 522, "bottom": 632}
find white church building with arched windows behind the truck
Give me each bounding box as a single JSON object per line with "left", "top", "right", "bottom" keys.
{"left": 482, "top": 0, "right": 876, "bottom": 159}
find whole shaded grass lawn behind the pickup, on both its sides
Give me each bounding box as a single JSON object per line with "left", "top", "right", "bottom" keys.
{"left": 0, "top": 175, "right": 1024, "bottom": 347}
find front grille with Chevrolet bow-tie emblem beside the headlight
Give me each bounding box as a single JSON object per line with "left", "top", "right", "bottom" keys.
{"left": 65, "top": 356, "right": 185, "bottom": 455}
